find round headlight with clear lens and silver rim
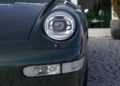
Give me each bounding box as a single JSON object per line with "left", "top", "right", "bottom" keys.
{"left": 44, "top": 11, "right": 75, "bottom": 40}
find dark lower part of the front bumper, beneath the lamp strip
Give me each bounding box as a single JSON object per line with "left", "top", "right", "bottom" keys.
{"left": 0, "top": 67, "right": 83, "bottom": 86}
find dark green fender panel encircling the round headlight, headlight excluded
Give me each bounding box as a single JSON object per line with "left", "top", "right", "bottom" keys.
{"left": 29, "top": 4, "right": 84, "bottom": 49}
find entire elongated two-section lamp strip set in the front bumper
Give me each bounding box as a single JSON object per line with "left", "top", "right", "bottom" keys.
{"left": 23, "top": 57, "right": 85, "bottom": 77}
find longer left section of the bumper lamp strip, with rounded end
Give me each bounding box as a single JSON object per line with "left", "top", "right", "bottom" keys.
{"left": 23, "top": 64, "right": 60, "bottom": 77}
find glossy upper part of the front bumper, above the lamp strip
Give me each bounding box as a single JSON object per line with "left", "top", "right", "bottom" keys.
{"left": 0, "top": 40, "right": 80, "bottom": 66}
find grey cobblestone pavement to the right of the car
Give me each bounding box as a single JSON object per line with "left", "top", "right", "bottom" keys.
{"left": 88, "top": 39, "right": 120, "bottom": 86}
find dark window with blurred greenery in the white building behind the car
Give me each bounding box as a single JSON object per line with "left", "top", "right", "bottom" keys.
{"left": 78, "top": 0, "right": 112, "bottom": 28}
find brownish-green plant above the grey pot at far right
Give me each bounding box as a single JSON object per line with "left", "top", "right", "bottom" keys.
{"left": 111, "top": 0, "right": 120, "bottom": 19}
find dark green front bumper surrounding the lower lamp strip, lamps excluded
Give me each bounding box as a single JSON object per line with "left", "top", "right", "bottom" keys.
{"left": 0, "top": 42, "right": 83, "bottom": 86}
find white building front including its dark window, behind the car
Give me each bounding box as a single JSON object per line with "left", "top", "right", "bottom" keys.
{"left": 71, "top": 0, "right": 115, "bottom": 37}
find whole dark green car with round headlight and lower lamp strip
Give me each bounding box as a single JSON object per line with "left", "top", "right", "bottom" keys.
{"left": 0, "top": 0, "right": 88, "bottom": 86}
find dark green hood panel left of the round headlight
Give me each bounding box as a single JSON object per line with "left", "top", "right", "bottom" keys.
{"left": 0, "top": 2, "right": 46, "bottom": 40}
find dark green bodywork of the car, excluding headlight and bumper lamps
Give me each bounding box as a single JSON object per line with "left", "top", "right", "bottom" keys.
{"left": 0, "top": 0, "right": 88, "bottom": 86}
